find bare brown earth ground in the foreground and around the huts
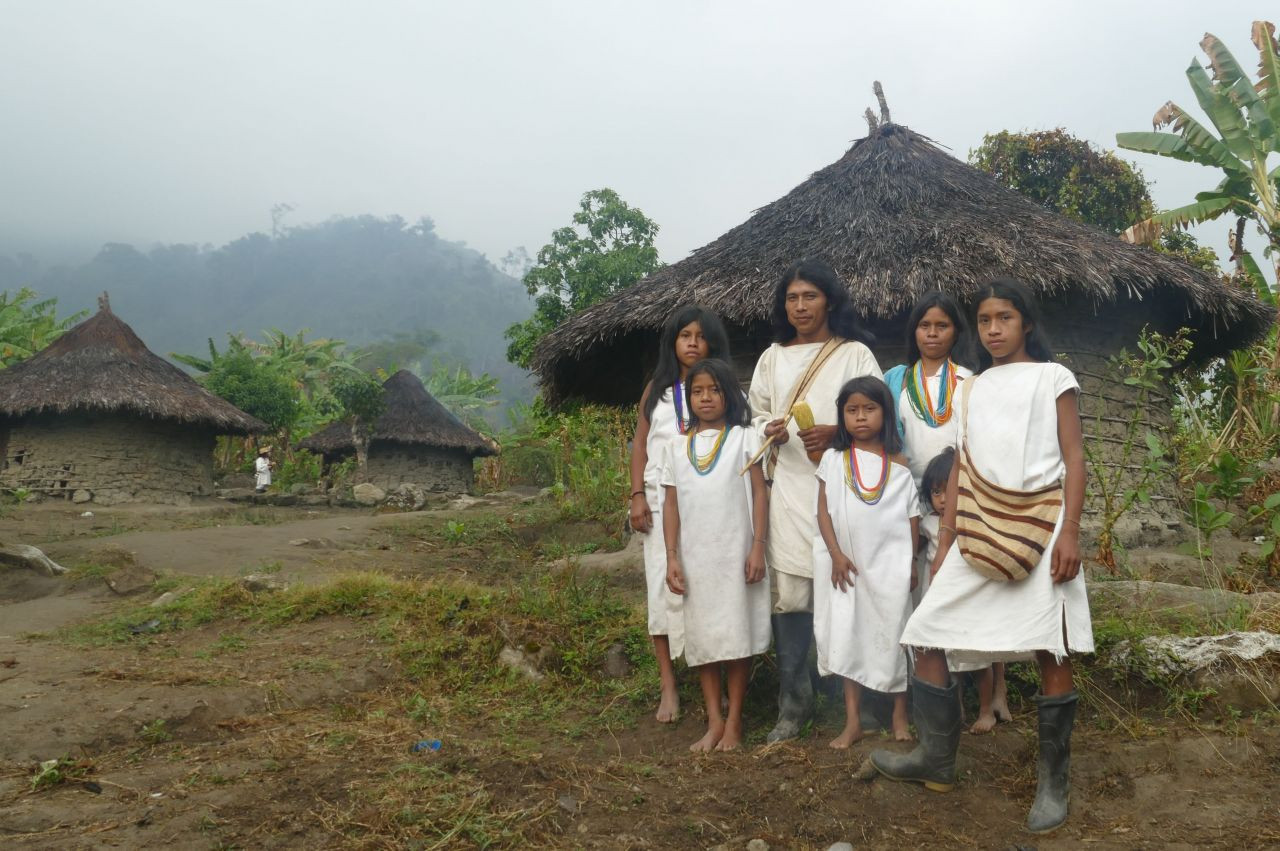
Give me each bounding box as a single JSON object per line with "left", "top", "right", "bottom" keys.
{"left": 0, "top": 504, "right": 1280, "bottom": 848}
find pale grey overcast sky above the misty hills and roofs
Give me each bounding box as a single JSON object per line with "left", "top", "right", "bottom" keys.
{"left": 0, "top": 0, "right": 1280, "bottom": 267}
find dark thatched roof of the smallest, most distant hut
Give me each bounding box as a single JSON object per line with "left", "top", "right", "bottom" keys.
{"left": 298, "top": 370, "right": 498, "bottom": 456}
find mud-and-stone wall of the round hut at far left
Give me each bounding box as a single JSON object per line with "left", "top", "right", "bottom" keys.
{"left": 0, "top": 415, "right": 214, "bottom": 505}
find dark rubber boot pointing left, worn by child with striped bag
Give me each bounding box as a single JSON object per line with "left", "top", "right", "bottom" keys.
{"left": 872, "top": 677, "right": 961, "bottom": 792}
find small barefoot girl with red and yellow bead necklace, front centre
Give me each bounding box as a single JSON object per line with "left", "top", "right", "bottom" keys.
{"left": 814, "top": 376, "right": 920, "bottom": 747}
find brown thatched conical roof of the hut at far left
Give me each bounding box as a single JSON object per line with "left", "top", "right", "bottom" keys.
{"left": 0, "top": 293, "right": 268, "bottom": 434}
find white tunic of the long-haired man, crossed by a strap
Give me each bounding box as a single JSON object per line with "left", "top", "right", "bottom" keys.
{"left": 749, "top": 342, "right": 883, "bottom": 577}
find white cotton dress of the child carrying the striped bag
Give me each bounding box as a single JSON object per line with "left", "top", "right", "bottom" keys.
{"left": 902, "top": 362, "right": 1093, "bottom": 663}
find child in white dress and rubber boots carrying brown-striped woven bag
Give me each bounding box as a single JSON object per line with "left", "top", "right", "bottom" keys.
{"left": 872, "top": 278, "right": 1093, "bottom": 833}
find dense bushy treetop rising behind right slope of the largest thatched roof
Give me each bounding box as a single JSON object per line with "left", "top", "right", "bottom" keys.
{"left": 969, "top": 128, "right": 1152, "bottom": 233}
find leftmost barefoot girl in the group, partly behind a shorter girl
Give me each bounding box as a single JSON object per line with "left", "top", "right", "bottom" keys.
{"left": 630, "top": 305, "right": 728, "bottom": 724}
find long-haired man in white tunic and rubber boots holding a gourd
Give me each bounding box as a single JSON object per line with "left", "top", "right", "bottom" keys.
{"left": 750, "top": 260, "right": 881, "bottom": 742}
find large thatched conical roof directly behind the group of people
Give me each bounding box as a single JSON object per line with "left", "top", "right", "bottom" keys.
{"left": 534, "top": 124, "right": 1274, "bottom": 401}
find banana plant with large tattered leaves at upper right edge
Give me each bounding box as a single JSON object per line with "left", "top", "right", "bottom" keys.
{"left": 1116, "top": 20, "right": 1280, "bottom": 305}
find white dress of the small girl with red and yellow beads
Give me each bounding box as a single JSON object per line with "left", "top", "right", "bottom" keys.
{"left": 813, "top": 449, "right": 920, "bottom": 692}
